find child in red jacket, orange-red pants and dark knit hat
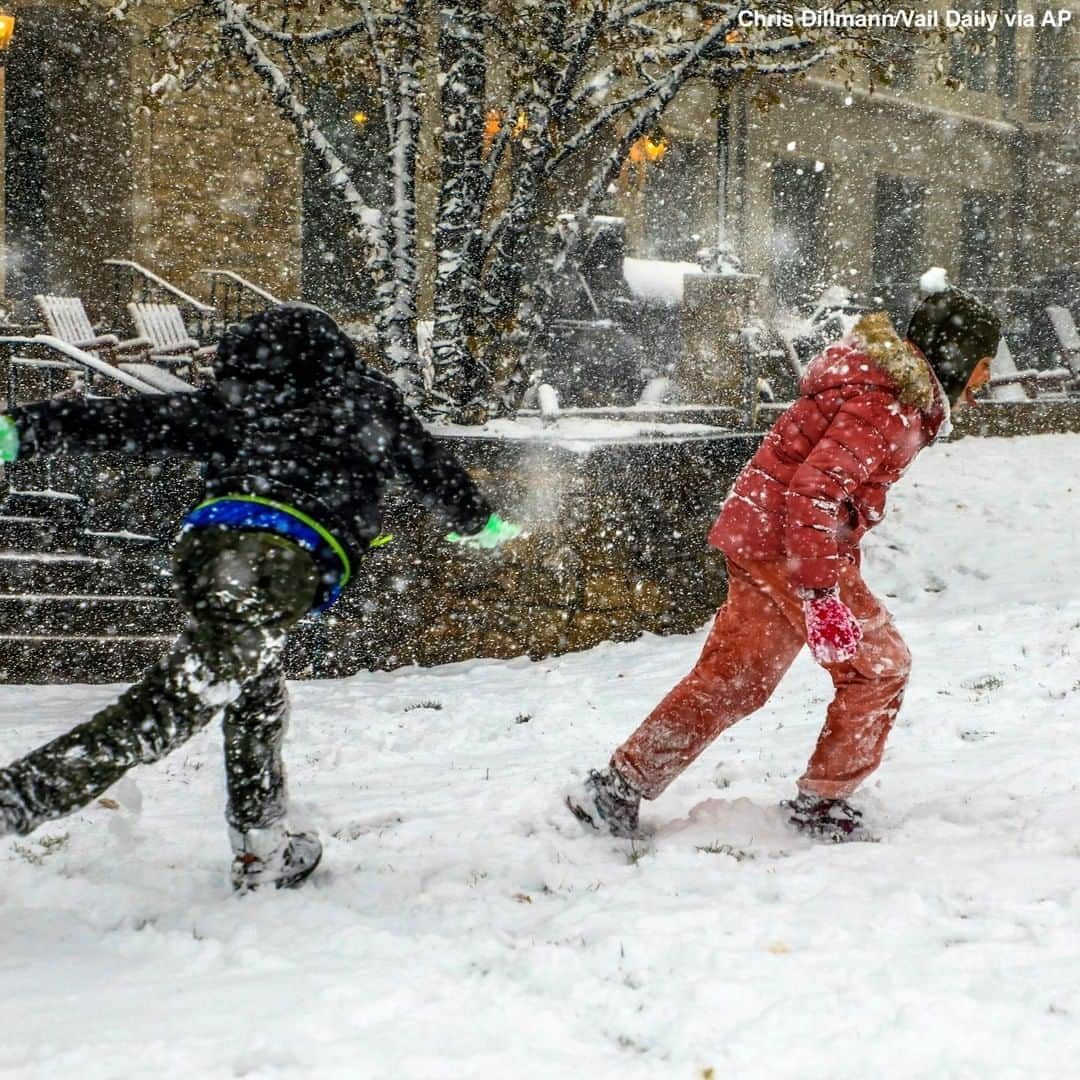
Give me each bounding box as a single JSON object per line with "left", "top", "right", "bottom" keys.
{"left": 567, "top": 289, "right": 1000, "bottom": 839}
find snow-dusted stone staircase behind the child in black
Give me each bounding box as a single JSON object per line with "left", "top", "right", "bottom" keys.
{"left": 0, "top": 466, "right": 326, "bottom": 684}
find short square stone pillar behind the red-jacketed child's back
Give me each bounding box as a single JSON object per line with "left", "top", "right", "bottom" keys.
{"left": 674, "top": 273, "right": 760, "bottom": 415}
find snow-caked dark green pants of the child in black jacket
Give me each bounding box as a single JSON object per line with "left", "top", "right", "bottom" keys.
{"left": 0, "top": 528, "right": 320, "bottom": 834}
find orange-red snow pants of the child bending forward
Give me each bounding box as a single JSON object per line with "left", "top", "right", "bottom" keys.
{"left": 611, "top": 558, "right": 912, "bottom": 799}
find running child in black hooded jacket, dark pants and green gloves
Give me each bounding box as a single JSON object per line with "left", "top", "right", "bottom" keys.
{"left": 0, "top": 305, "right": 518, "bottom": 891}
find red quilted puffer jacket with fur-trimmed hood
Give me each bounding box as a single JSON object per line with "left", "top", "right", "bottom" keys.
{"left": 708, "top": 313, "right": 948, "bottom": 589}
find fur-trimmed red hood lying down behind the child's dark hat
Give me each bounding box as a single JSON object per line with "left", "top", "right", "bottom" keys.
{"left": 801, "top": 311, "right": 939, "bottom": 413}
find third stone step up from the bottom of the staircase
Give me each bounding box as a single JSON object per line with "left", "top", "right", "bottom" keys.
{"left": 0, "top": 552, "right": 173, "bottom": 596}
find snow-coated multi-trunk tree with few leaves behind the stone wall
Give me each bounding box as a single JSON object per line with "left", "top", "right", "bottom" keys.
{"left": 123, "top": 0, "right": 937, "bottom": 422}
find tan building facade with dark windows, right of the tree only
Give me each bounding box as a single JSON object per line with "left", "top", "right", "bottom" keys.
{"left": 625, "top": 6, "right": 1080, "bottom": 313}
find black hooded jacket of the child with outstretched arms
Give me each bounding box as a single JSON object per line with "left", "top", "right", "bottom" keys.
{"left": 10, "top": 305, "right": 491, "bottom": 561}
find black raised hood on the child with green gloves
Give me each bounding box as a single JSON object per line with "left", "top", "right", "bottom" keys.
{"left": 214, "top": 303, "right": 362, "bottom": 396}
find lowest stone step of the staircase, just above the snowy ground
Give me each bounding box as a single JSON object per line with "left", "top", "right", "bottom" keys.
{"left": 0, "top": 635, "right": 173, "bottom": 682}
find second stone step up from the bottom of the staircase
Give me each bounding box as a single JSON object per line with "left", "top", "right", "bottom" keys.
{"left": 0, "top": 594, "right": 185, "bottom": 637}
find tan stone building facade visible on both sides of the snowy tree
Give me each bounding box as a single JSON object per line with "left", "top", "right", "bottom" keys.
{"left": 3, "top": 0, "right": 1080, "bottom": 326}
